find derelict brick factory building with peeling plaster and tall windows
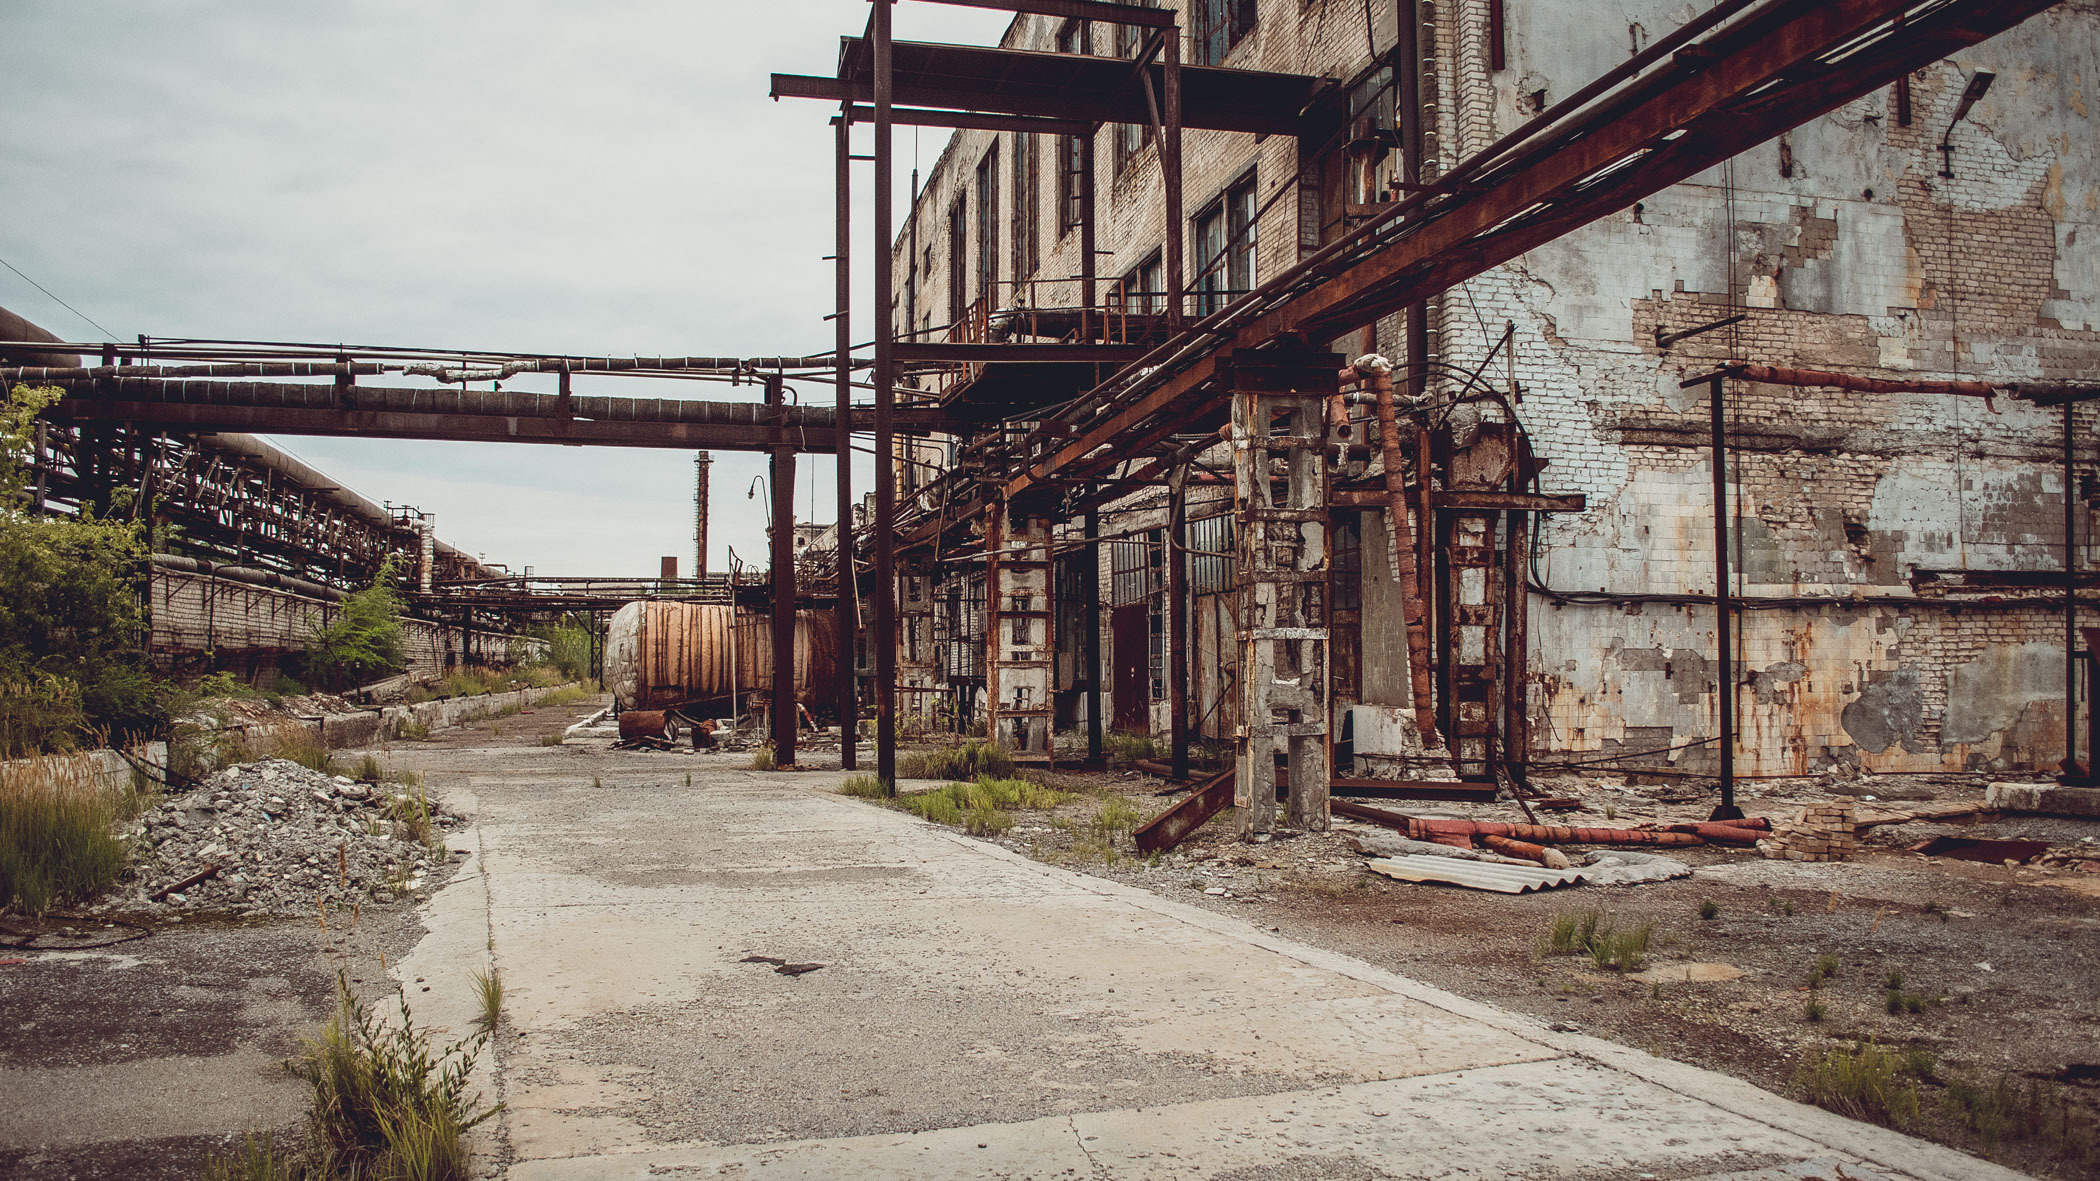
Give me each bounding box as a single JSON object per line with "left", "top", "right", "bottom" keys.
{"left": 842, "top": 0, "right": 2100, "bottom": 778}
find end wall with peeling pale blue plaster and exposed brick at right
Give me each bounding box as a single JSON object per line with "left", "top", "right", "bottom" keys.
{"left": 1486, "top": 0, "right": 2100, "bottom": 775}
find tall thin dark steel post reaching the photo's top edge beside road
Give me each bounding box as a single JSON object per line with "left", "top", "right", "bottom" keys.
{"left": 867, "top": 0, "right": 897, "bottom": 792}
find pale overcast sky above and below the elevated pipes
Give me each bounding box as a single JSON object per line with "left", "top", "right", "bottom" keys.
{"left": 0, "top": 0, "right": 1008, "bottom": 574}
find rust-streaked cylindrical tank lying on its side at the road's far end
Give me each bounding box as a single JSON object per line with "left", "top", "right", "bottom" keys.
{"left": 605, "top": 599, "right": 838, "bottom": 710}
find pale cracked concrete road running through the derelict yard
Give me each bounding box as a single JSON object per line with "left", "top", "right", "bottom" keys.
{"left": 395, "top": 744, "right": 2014, "bottom": 1181}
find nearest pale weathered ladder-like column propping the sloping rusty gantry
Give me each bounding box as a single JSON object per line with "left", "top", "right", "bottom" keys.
{"left": 1229, "top": 351, "right": 1340, "bottom": 838}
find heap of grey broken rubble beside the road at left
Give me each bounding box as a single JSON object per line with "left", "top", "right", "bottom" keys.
{"left": 111, "top": 759, "right": 449, "bottom": 914}
